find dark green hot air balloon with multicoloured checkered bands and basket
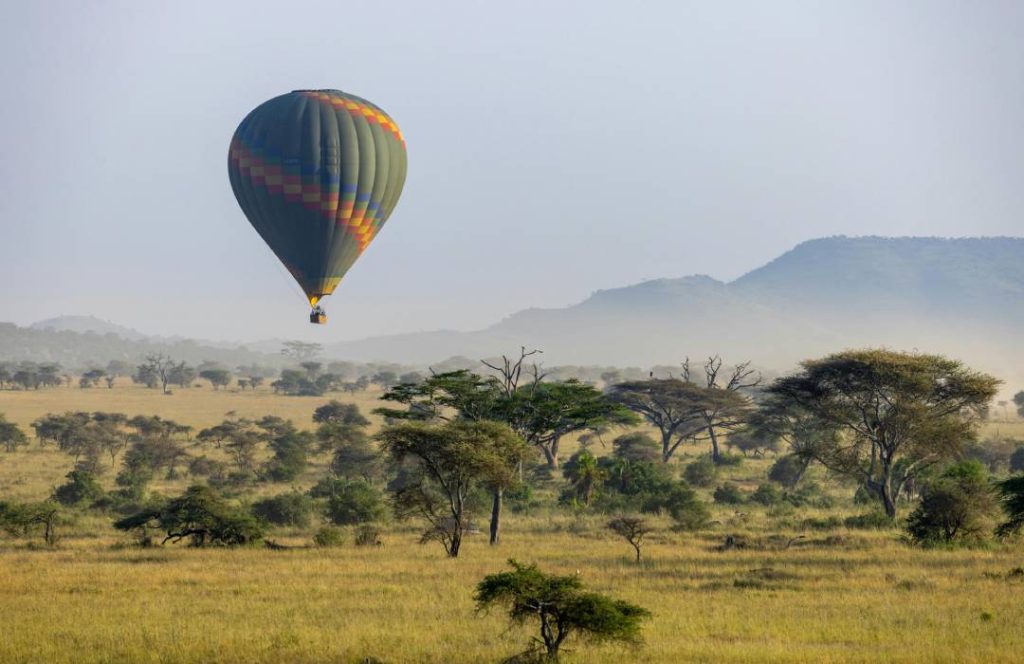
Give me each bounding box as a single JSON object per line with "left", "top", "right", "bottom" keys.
{"left": 227, "top": 90, "right": 406, "bottom": 324}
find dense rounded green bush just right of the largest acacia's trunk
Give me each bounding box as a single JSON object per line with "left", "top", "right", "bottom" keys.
{"left": 906, "top": 460, "right": 997, "bottom": 544}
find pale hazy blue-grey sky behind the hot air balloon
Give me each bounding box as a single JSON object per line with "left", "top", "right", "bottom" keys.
{"left": 0, "top": 0, "right": 1024, "bottom": 341}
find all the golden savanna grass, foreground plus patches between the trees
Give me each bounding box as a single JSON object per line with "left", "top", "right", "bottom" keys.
{"left": 0, "top": 384, "right": 1024, "bottom": 662}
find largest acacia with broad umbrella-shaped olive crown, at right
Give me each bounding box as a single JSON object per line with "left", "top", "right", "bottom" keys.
{"left": 768, "top": 349, "right": 999, "bottom": 518}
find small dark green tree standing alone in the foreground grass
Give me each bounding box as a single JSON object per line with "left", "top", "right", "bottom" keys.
{"left": 473, "top": 559, "right": 650, "bottom": 662}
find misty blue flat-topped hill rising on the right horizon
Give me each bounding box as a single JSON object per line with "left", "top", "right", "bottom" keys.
{"left": 330, "top": 237, "right": 1024, "bottom": 383}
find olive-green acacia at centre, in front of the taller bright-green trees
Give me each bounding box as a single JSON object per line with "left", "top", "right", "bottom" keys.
{"left": 378, "top": 420, "right": 525, "bottom": 557}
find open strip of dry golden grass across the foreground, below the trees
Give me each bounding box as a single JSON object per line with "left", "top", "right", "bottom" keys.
{"left": 0, "top": 518, "right": 1024, "bottom": 662}
